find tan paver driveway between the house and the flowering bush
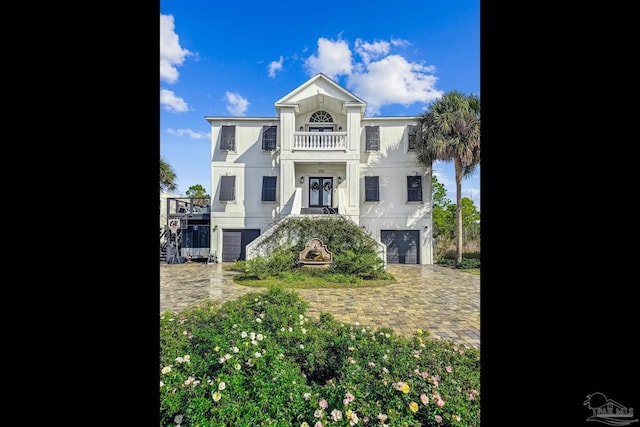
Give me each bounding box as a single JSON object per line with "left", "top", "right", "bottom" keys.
{"left": 160, "top": 262, "right": 480, "bottom": 348}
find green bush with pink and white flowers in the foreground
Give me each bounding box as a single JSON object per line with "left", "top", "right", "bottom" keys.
{"left": 159, "top": 288, "right": 480, "bottom": 427}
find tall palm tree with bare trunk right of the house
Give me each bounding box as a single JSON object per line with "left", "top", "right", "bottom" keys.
{"left": 416, "top": 90, "right": 480, "bottom": 265}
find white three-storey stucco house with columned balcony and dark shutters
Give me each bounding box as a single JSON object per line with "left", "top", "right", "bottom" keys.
{"left": 205, "top": 74, "right": 433, "bottom": 264}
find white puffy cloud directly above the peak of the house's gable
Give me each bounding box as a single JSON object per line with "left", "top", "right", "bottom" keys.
{"left": 304, "top": 37, "right": 351, "bottom": 79}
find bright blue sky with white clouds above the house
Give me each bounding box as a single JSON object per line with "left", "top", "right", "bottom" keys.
{"left": 160, "top": 0, "right": 480, "bottom": 209}
